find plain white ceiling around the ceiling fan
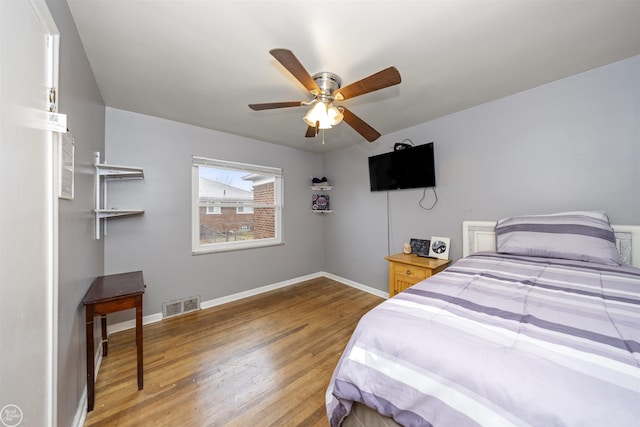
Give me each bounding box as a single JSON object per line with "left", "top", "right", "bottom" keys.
{"left": 62, "top": 0, "right": 640, "bottom": 152}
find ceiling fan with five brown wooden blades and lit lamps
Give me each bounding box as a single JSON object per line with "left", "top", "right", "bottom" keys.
{"left": 249, "top": 49, "right": 401, "bottom": 142}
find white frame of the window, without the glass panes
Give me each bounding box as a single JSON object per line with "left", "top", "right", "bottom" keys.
{"left": 191, "top": 156, "right": 284, "bottom": 255}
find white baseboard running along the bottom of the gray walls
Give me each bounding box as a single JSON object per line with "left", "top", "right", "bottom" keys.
{"left": 72, "top": 271, "right": 389, "bottom": 427}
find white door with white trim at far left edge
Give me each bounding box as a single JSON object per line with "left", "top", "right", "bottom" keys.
{"left": 0, "top": 0, "right": 58, "bottom": 426}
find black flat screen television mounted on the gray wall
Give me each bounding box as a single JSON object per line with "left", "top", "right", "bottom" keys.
{"left": 369, "top": 142, "right": 436, "bottom": 191}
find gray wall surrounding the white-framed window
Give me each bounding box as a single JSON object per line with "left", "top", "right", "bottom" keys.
{"left": 104, "top": 108, "right": 323, "bottom": 323}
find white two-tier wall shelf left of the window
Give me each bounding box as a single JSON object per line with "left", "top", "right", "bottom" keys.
{"left": 94, "top": 152, "right": 144, "bottom": 239}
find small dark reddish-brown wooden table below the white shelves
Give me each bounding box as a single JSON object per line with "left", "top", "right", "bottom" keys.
{"left": 83, "top": 271, "right": 145, "bottom": 411}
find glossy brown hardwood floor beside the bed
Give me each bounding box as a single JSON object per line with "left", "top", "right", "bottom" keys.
{"left": 85, "top": 277, "right": 383, "bottom": 427}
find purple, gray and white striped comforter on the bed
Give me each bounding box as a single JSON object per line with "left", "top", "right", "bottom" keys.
{"left": 327, "top": 253, "right": 640, "bottom": 427}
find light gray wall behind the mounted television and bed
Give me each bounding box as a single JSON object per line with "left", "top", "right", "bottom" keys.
{"left": 324, "top": 57, "right": 640, "bottom": 290}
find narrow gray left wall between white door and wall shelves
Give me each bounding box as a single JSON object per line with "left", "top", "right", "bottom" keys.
{"left": 47, "top": 0, "right": 105, "bottom": 426}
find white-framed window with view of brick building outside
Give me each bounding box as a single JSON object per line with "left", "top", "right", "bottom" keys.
{"left": 192, "top": 156, "right": 282, "bottom": 254}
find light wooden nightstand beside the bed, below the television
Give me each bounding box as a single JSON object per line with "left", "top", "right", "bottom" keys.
{"left": 384, "top": 254, "right": 451, "bottom": 297}
